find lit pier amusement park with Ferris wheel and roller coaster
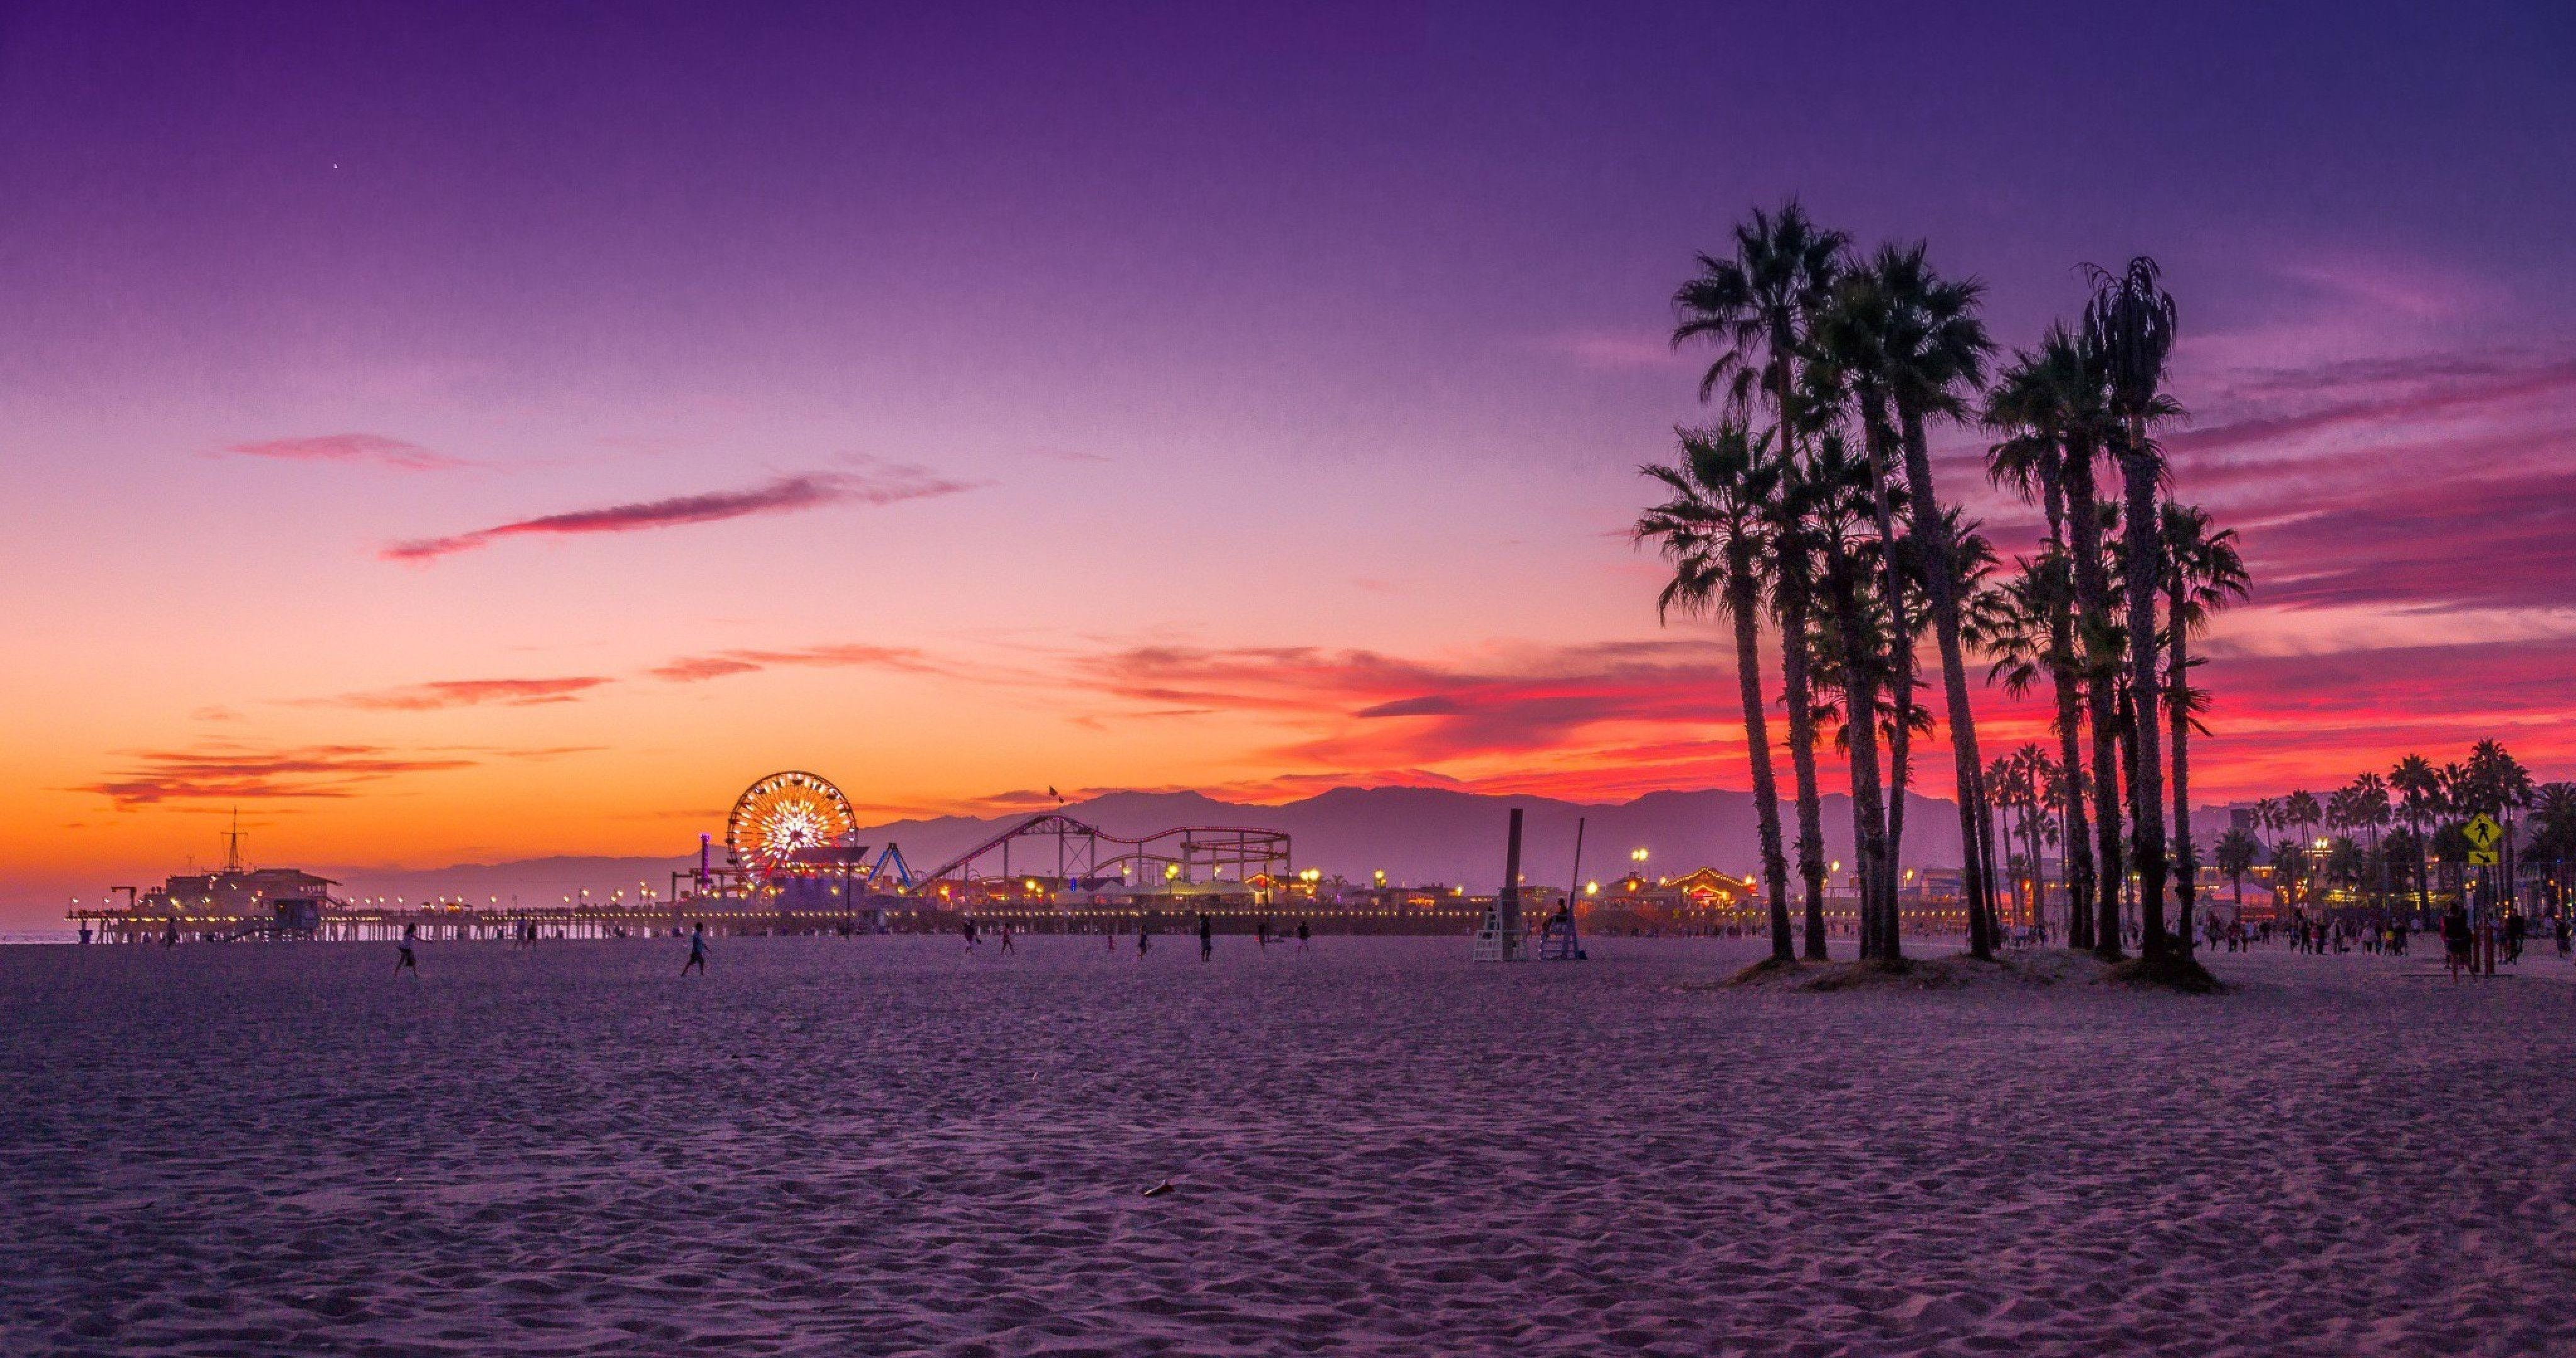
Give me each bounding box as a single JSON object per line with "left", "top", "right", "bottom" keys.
{"left": 685, "top": 771, "right": 1484, "bottom": 933}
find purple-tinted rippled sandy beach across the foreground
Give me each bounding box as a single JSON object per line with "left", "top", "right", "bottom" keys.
{"left": 0, "top": 938, "right": 2576, "bottom": 1355}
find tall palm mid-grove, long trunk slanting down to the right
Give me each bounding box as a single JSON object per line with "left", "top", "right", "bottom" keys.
{"left": 1836, "top": 245, "right": 1994, "bottom": 959}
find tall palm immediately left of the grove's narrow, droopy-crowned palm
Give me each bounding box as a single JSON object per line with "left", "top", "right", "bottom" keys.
{"left": 1986, "top": 343, "right": 2094, "bottom": 948}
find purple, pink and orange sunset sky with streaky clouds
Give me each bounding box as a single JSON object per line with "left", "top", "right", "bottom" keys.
{"left": 0, "top": 3, "right": 2576, "bottom": 922}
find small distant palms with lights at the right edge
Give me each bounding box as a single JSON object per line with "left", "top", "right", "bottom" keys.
{"left": 2216, "top": 739, "right": 2576, "bottom": 920}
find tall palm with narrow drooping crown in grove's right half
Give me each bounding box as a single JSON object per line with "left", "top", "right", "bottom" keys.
{"left": 2084, "top": 255, "right": 2179, "bottom": 961}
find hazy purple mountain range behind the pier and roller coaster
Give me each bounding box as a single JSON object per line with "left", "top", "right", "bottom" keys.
{"left": 317, "top": 788, "right": 1968, "bottom": 905}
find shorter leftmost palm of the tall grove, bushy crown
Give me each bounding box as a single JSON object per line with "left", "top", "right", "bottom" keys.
{"left": 1636, "top": 420, "right": 1796, "bottom": 961}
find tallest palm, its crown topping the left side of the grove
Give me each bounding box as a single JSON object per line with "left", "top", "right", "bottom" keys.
{"left": 1672, "top": 199, "right": 1847, "bottom": 961}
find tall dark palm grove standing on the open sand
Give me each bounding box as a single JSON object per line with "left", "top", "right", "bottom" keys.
{"left": 1636, "top": 204, "right": 2246, "bottom": 961}
